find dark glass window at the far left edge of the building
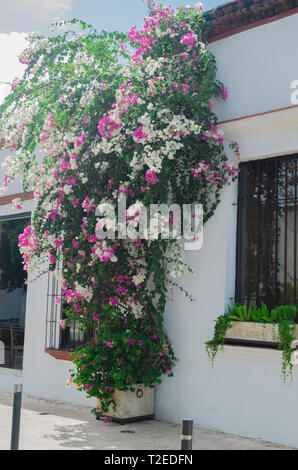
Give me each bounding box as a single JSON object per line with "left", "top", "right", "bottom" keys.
{"left": 0, "top": 214, "right": 30, "bottom": 369}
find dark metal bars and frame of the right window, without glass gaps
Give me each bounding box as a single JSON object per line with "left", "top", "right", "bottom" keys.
{"left": 234, "top": 153, "right": 298, "bottom": 305}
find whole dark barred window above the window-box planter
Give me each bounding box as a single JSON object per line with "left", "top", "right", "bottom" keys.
{"left": 236, "top": 155, "right": 298, "bottom": 307}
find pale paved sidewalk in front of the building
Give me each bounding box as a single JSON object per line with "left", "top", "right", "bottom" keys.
{"left": 0, "top": 393, "right": 294, "bottom": 450}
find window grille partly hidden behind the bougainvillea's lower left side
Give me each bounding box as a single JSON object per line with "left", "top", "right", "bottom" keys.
{"left": 45, "top": 266, "right": 93, "bottom": 351}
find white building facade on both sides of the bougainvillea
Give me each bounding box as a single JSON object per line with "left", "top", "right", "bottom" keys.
{"left": 0, "top": 0, "right": 298, "bottom": 448}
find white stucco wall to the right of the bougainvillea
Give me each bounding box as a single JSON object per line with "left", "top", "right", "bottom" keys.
{"left": 156, "top": 14, "right": 298, "bottom": 447}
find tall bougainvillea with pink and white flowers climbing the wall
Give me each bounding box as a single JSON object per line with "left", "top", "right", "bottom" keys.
{"left": 0, "top": 2, "right": 238, "bottom": 414}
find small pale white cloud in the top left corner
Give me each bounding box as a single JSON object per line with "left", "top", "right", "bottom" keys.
{"left": 5, "top": 0, "right": 74, "bottom": 20}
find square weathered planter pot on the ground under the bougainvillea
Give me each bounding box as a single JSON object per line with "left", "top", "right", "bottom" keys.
{"left": 96, "top": 384, "right": 154, "bottom": 424}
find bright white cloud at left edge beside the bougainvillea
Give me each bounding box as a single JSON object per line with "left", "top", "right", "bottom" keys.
{"left": 0, "top": 33, "right": 27, "bottom": 103}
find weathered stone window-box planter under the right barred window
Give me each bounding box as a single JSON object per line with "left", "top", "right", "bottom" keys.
{"left": 225, "top": 322, "right": 298, "bottom": 344}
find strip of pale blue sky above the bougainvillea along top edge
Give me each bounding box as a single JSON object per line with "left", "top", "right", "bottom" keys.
{"left": 0, "top": 0, "right": 226, "bottom": 33}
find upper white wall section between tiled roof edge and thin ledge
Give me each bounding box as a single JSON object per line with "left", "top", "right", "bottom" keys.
{"left": 209, "top": 14, "right": 298, "bottom": 121}
